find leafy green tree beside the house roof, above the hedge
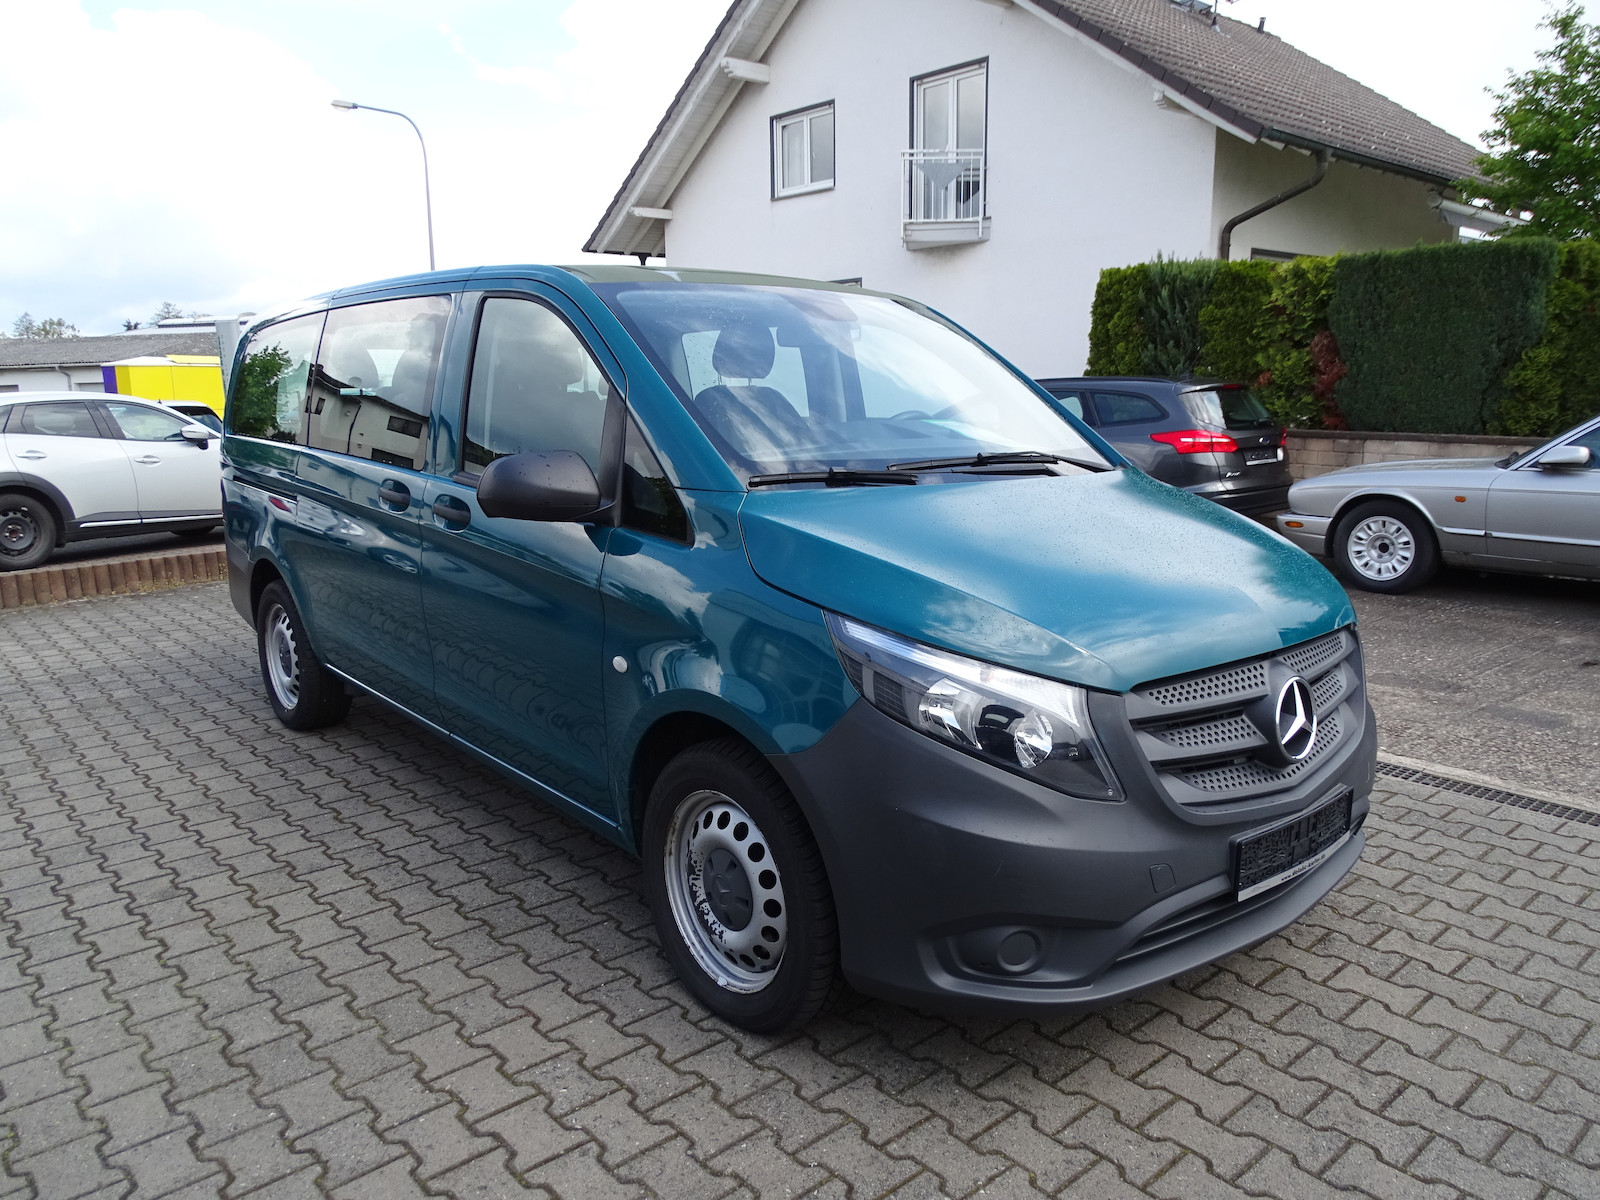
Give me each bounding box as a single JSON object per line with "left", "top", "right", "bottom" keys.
{"left": 1456, "top": 0, "right": 1600, "bottom": 240}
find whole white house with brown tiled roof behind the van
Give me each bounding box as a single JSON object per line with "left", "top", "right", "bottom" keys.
{"left": 584, "top": 0, "right": 1496, "bottom": 374}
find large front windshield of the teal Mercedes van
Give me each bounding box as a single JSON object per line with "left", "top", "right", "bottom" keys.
{"left": 595, "top": 283, "right": 1106, "bottom": 480}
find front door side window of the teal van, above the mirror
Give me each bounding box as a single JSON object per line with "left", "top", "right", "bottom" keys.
{"left": 461, "top": 296, "right": 611, "bottom": 475}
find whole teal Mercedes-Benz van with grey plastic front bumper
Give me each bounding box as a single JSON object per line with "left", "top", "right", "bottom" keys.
{"left": 222, "top": 267, "right": 1376, "bottom": 1030}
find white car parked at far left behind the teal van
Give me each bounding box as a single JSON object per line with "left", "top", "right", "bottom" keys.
{"left": 0, "top": 392, "right": 222, "bottom": 571}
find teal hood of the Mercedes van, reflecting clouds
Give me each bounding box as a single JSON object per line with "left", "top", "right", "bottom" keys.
{"left": 739, "top": 470, "right": 1355, "bottom": 691}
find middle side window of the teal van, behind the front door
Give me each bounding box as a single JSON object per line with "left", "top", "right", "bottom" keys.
{"left": 306, "top": 296, "right": 450, "bottom": 470}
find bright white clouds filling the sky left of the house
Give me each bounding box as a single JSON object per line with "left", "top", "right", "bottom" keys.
{"left": 0, "top": 0, "right": 725, "bottom": 333}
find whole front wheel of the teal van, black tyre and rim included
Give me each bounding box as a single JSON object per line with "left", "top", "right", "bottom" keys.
{"left": 643, "top": 738, "right": 838, "bottom": 1034}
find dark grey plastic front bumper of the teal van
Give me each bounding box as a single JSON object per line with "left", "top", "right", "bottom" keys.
{"left": 774, "top": 701, "right": 1376, "bottom": 1013}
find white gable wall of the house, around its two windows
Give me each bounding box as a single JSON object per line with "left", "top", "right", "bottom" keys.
{"left": 667, "top": 0, "right": 1216, "bottom": 376}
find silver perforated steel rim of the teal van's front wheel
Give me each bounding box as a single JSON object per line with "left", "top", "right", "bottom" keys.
{"left": 662, "top": 790, "right": 789, "bottom": 994}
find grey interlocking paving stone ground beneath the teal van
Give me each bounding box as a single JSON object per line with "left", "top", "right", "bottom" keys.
{"left": 0, "top": 586, "right": 1600, "bottom": 1200}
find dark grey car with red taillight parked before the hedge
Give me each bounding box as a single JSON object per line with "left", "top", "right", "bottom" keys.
{"left": 1038, "top": 376, "right": 1293, "bottom": 514}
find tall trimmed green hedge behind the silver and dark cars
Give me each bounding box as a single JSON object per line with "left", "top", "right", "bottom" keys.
{"left": 1088, "top": 238, "right": 1600, "bottom": 435}
